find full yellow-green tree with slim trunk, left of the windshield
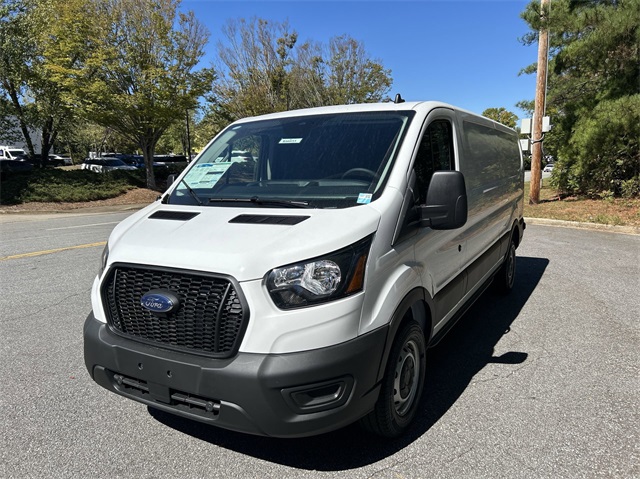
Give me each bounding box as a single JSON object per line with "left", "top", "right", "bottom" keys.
{"left": 66, "top": 0, "right": 214, "bottom": 189}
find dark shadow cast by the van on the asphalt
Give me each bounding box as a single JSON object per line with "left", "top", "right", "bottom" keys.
{"left": 148, "top": 257, "right": 549, "bottom": 471}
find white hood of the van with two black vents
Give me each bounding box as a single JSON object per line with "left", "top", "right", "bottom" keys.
{"left": 109, "top": 203, "right": 380, "bottom": 281}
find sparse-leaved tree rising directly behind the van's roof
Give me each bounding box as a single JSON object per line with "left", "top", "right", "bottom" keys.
{"left": 205, "top": 18, "right": 391, "bottom": 125}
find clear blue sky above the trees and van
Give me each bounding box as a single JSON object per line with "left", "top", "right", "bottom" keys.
{"left": 181, "top": 0, "right": 537, "bottom": 118}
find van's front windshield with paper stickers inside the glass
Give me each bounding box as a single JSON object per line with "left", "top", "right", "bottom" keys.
{"left": 167, "top": 111, "right": 413, "bottom": 208}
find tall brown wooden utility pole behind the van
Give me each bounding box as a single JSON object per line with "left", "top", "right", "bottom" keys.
{"left": 529, "top": 0, "right": 550, "bottom": 205}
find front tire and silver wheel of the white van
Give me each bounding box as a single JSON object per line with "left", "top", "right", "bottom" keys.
{"left": 361, "top": 321, "right": 426, "bottom": 438}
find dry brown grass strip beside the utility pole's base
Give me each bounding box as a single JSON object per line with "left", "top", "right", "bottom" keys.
{"left": 524, "top": 182, "right": 640, "bottom": 227}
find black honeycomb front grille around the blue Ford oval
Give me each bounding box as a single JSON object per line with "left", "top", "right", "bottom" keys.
{"left": 102, "top": 265, "right": 249, "bottom": 358}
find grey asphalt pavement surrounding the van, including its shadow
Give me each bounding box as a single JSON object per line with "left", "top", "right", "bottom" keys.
{"left": 0, "top": 213, "right": 640, "bottom": 478}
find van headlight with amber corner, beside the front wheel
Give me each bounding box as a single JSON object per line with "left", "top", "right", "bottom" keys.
{"left": 267, "top": 236, "right": 373, "bottom": 309}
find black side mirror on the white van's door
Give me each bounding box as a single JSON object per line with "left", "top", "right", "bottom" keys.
{"left": 419, "top": 171, "right": 468, "bottom": 230}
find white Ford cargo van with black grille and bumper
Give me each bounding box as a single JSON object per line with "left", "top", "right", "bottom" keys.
{"left": 84, "top": 102, "right": 525, "bottom": 437}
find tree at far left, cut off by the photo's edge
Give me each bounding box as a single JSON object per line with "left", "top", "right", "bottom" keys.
{"left": 0, "top": 0, "right": 88, "bottom": 164}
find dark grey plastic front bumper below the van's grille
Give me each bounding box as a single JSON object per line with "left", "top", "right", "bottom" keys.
{"left": 84, "top": 314, "right": 387, "bottom": 437}
